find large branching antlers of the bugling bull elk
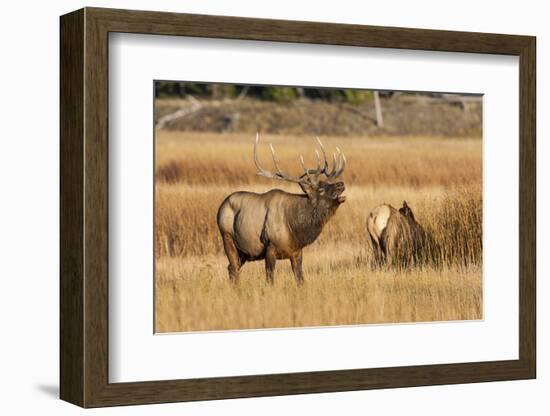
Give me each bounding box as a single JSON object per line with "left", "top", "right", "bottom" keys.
{"left": 254, "top": 133, "right": 346, "bottom": 185}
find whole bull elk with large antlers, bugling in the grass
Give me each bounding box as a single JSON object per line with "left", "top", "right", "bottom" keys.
{"left": 217, "top": 134, "right": 346, "bottom": 284}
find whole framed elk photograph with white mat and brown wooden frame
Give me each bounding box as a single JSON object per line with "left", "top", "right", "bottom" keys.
{"left": 60, "top": 8, "right": 536, "bottom": 407}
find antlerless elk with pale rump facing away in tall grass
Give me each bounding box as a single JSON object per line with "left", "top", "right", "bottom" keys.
{"left": 367, "top": 201, "right": 440, "bottom": 269}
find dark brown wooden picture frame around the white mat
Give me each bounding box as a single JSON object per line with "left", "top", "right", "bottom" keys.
{"left": 60, "top": 8, "right": 536, "bottom": 407}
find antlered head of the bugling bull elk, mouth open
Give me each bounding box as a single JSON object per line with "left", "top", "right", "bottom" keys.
{"left": 254, "top": 133, "right": 346, "bottom": 208}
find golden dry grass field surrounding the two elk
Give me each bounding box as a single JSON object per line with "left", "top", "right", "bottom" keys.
{"left": 155, "top": 130, "right": 482, "bottom": 332}
